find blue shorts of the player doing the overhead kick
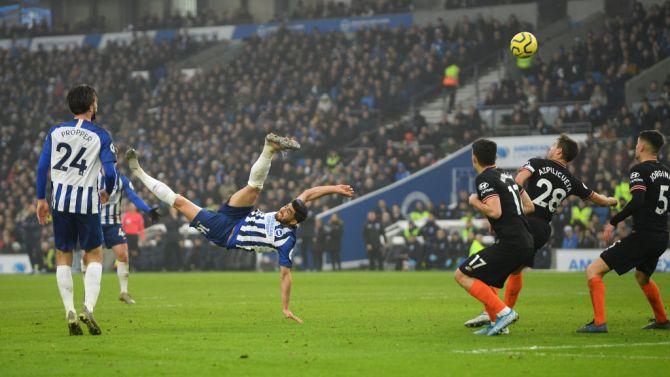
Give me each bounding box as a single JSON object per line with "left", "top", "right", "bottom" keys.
{"left": 189, "top": 203, "right": 254, "bottom": 247}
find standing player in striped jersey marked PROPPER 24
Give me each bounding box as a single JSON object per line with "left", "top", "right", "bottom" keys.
{"left": 37, "top": 85, "right": 116, "bottom": 335}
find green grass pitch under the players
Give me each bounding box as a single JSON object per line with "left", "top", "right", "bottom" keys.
{"left": 0, "top": 272, "right": 670, "bottom": 377}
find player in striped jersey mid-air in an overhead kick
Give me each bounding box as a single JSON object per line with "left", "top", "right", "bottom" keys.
{"left": 126, "top": 134, "right": 354, "bottom": 323}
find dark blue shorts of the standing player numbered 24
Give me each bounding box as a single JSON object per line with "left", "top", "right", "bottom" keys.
{"left": 52, "top": 211, "right": 102, "bottom": 252}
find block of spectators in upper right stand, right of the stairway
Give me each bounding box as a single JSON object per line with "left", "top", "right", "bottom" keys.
{"left": 484, "top": 2, "right": 670, "bottom": 109}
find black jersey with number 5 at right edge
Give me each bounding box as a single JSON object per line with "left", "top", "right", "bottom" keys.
{"left": 630, "top": 161, "right": 670, "bottom": 232}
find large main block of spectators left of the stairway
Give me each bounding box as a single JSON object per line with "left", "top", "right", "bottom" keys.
{"left": 0, "top": 13, "right": 528, "bottom": 270}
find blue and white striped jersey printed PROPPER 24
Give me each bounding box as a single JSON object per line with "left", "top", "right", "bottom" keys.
{"left": 42, "top": 119, "right": 116, "bottom": 214}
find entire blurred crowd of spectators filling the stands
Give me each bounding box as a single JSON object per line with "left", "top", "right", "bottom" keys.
{"left": 0, "top": 0, "right": 670, "bottom": 270}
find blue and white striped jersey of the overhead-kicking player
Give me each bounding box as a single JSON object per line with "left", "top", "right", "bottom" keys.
{"left": 227, "top": 210, "right": 296, "bottom": 268}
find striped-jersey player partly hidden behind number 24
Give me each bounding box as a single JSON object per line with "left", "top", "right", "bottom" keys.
{"left": 81, "top": 173, "right": 160, "bottom": 304}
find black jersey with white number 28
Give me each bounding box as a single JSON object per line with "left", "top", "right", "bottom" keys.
{"left": 520, "top": 158, "right": 593, "bottom": 221}
